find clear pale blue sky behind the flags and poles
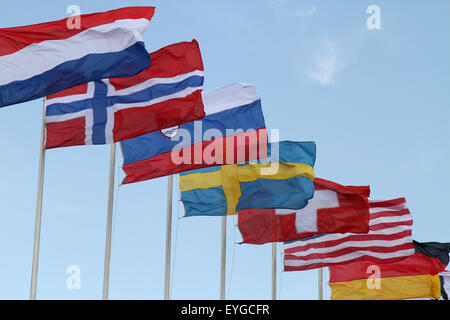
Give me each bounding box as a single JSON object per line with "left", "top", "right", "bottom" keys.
{"left": 0, "top": 0, "right": 450, "bottom": 299}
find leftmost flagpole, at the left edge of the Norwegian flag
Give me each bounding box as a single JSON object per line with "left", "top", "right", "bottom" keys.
{"left": 30, "top": 97, "right": 46, "bottom": 300}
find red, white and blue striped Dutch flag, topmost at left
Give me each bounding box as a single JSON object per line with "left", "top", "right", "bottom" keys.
{"left": 0, "top": 7, "right": 155, "bottom": 107}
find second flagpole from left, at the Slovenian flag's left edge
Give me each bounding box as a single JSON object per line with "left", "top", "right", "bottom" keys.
{"left": 103, "top": 143, "right": 116, "bottom": 300}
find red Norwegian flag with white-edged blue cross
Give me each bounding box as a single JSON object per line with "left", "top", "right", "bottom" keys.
{"left": 45, "top": 40, "right": 205, "bottom": 149}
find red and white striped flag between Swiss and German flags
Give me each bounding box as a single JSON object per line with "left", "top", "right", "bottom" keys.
{"left": 283, "top": 198, "right": 414, "bottom": 271}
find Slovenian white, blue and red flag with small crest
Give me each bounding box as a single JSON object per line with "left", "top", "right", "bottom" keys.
{"left": 120, "top": 83, "right": 267, "bottom": 184}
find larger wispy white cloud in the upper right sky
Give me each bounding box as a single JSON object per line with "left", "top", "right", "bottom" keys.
{"left": 307, "top": 39, "right": 344, "bottom": 85}
